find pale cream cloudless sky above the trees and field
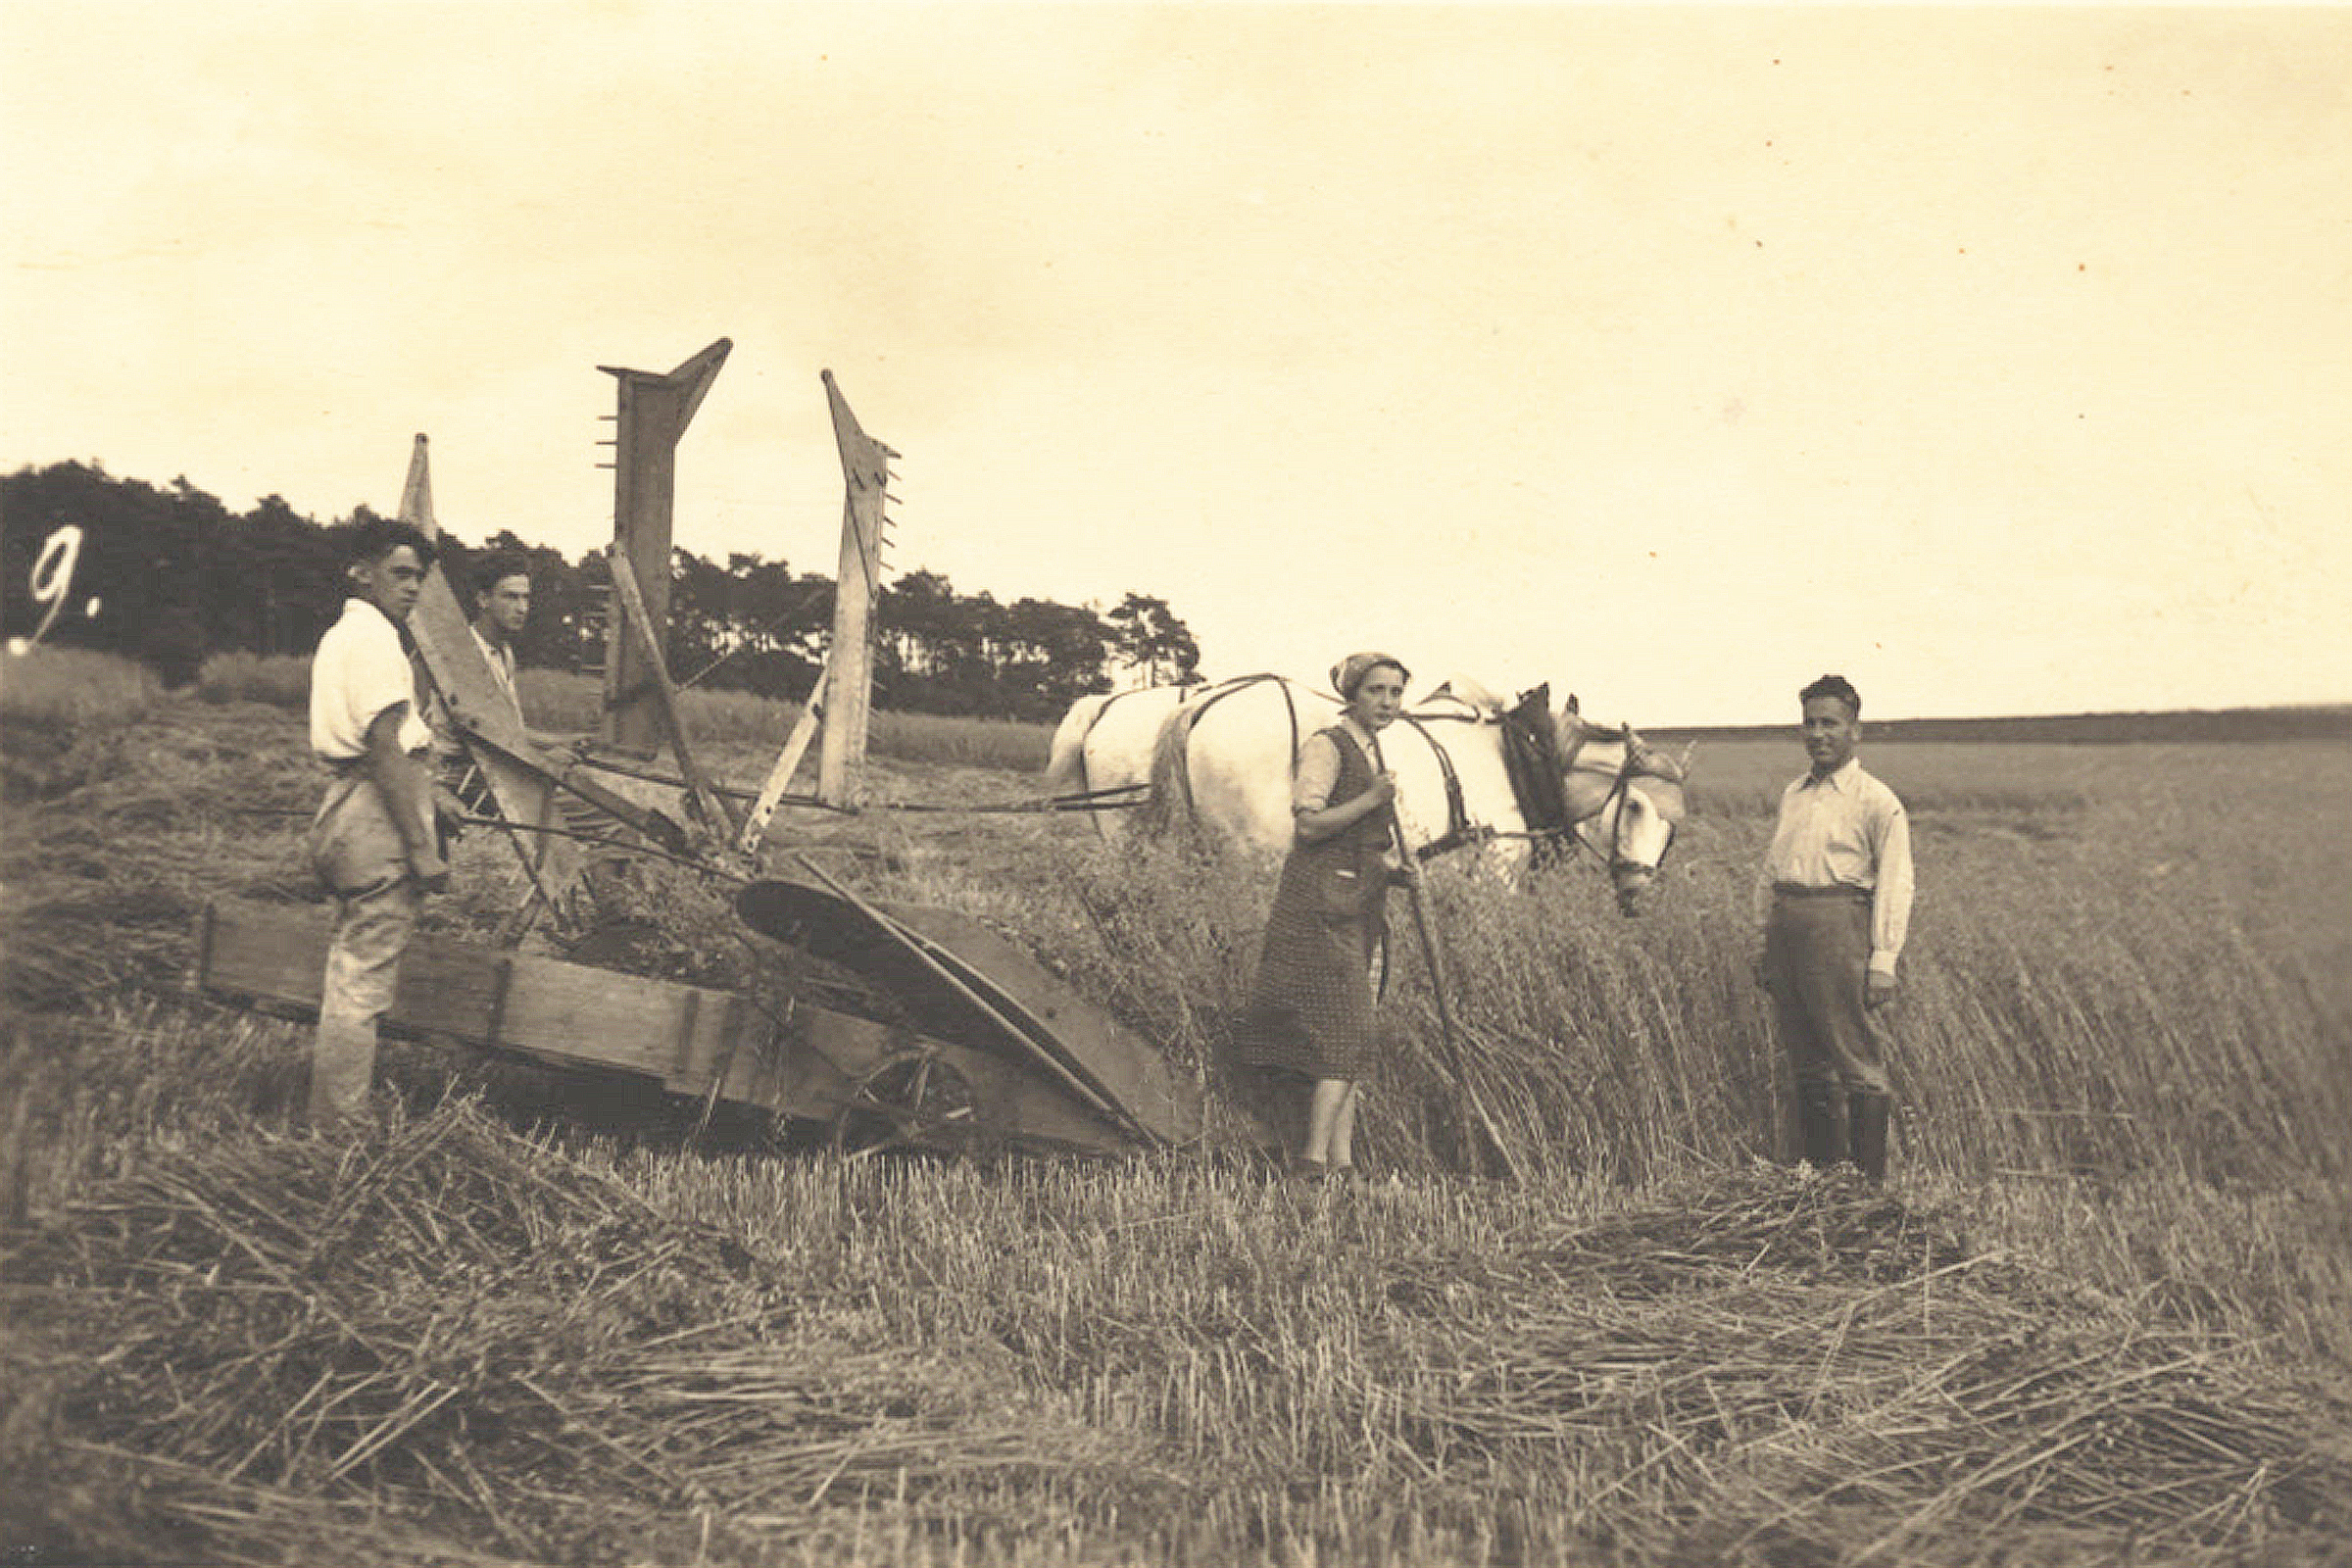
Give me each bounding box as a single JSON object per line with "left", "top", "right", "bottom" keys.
{"left": 0, "top": 0, "right": 2352, "bottom": 726}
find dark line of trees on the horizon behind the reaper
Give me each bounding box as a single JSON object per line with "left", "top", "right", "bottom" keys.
{"left": 0, "top": 464, "right": 1200, "bottom": 719}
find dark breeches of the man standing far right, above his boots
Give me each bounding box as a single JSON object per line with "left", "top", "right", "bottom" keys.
{"left": 1764, "top": 889, "right": 1888, "bottom": 1096}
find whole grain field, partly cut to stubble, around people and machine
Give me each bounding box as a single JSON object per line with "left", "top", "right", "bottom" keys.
{"left": 0, "top": 649, "right": 2352, "bottom": 1563}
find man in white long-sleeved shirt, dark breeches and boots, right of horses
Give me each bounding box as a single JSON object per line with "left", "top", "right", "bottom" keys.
{"left": 1757, "top": 674, "right": 1912, "bottom": 1183}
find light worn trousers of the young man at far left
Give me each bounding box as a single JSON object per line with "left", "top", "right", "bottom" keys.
{"left": 311, "top": 771, "right": 430, "bottom": 1128}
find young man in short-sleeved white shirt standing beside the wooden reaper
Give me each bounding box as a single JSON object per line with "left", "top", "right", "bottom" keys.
{"left": 311, "top": 517, "right": 449, "bottom": 1131}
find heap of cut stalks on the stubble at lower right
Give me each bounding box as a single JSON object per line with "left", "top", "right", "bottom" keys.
{"left": 1393, "top": 1171, "right": 2352, "bottom": 1561}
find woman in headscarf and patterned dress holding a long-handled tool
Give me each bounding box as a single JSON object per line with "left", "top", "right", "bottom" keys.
{"left": 1237, "top": 654, "right": 1413, "bottom": 1175}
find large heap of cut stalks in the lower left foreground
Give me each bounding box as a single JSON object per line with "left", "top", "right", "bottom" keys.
{"left": 0, "top": 1104, "right": 1129, "bottom": 1563}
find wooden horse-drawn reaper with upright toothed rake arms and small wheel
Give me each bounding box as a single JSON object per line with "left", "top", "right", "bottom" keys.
{"left": 195, "top": 360, "right": 1201, "bottom": 1154}
